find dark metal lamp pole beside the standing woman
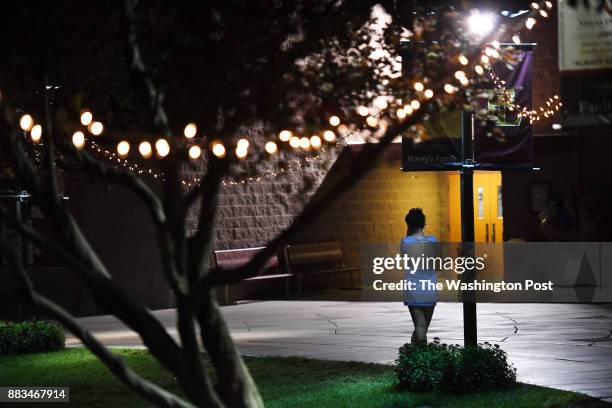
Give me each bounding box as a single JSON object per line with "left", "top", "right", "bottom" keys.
{"left": 460, "top": 112, "right": 477, "bottom": 345}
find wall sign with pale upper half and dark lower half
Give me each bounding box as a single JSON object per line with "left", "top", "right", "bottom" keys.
{"left": 559, "top": 0, "right": 612, "bottom": 128}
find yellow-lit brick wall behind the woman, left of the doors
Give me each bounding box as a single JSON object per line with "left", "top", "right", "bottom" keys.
{"left": 296, "top": 155, "right": 449, "bottom": 265}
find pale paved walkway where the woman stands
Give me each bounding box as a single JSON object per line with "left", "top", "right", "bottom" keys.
{"left": 68, "top": 301, "right": 612, "bottom": 401}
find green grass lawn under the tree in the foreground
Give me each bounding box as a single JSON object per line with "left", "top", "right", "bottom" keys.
{"left": 0, "top": 349, "right": 612, "bottom": 408}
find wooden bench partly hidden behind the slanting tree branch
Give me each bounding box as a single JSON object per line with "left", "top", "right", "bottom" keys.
{"left": 212, "top": 247, "right": 292, "bottom": 303}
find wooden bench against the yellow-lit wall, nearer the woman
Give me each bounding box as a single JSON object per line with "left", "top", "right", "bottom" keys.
{"left": 283, "top": 242, "right": 360, "bottom": 295}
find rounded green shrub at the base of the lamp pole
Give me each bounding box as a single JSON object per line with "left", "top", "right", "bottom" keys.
{"left": 395, "top": 338, "right": 516, "bottom": 392}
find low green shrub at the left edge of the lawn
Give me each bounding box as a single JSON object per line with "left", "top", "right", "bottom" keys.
{"left": 0, "top": 320, "right": 66, "bottom": 355}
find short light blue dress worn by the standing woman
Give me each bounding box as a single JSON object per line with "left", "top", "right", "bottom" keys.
{"left": 400, "top": 235, "right": 438, "bottom": 306}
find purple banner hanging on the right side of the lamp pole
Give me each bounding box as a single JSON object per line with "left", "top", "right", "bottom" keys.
{"left": 474, "top": 50, "right": 533, "bottom": 168}
